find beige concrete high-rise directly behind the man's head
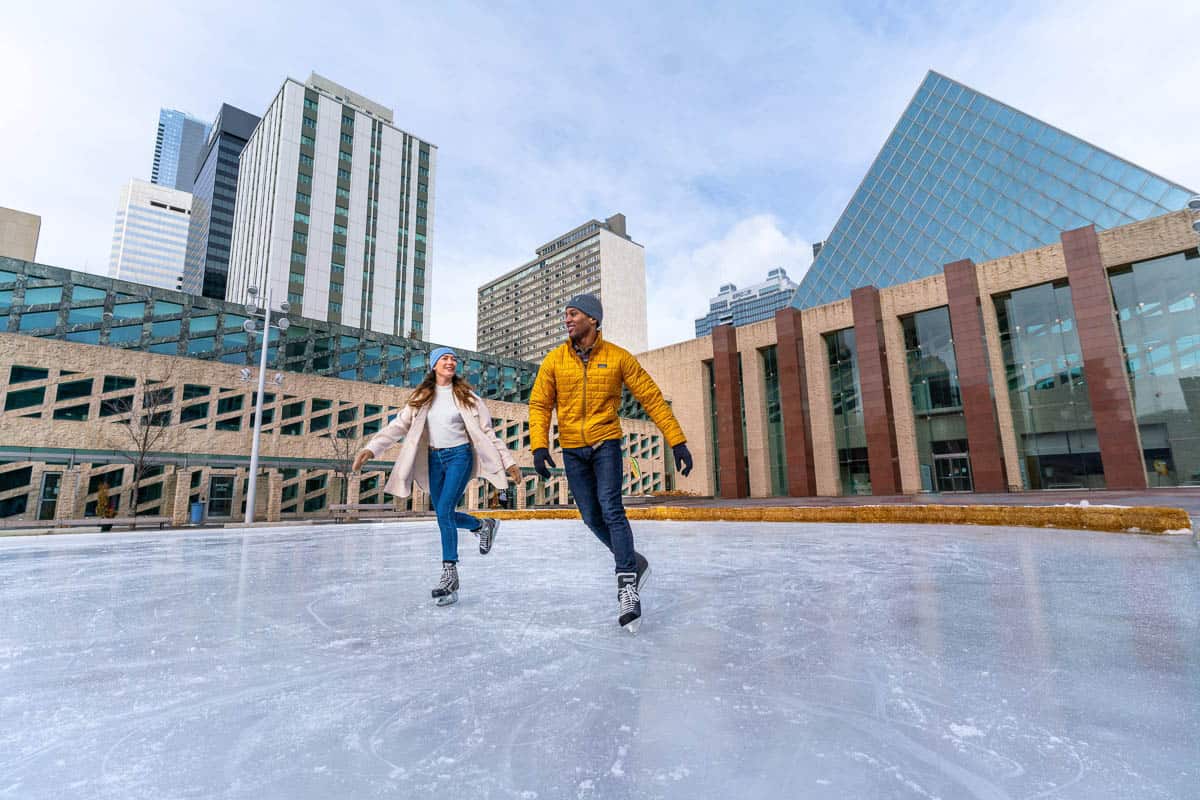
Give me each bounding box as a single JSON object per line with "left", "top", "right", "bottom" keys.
{"left": 476, "top": 213, "right": 648, "bottom": 361}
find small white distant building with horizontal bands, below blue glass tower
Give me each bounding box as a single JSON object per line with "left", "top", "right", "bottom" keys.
{"left": 108, "top": 180, "right": 192, "bottom": 289}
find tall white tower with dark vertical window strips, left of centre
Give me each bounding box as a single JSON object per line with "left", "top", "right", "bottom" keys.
{"left": 226, "top": 73, "right": 437, "bottom": 338}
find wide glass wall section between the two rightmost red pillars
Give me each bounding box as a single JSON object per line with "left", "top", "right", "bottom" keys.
{"left": 994, "top": 281, "right": 1104, "bottom": 489}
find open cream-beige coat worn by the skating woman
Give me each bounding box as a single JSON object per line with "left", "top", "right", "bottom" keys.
{"left": 366, "top": 395, "right": 516, "bottom": 498}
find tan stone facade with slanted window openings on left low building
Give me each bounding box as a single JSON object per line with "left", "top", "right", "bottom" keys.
{"left": 0, "top": 333, "right": 671, "bottom": 523}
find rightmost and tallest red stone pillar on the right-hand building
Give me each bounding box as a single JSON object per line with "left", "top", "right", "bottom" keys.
{"left": 1062, "top": 225, "right": 1146, "bottom": 489}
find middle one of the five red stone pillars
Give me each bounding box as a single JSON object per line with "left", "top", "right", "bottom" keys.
{"left": 850, "top": 287, "right": 900, "bottom": 494}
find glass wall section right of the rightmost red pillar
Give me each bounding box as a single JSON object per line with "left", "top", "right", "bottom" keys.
{"left": 1109, "top": 251, "right": 1200, "bottom": 487}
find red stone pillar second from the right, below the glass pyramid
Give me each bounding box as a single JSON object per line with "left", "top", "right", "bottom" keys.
{"left": 943, "top": 259, "right": 1008, "bottom": 492}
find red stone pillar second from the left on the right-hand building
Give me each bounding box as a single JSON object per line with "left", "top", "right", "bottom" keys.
{"left": 775, "top": 308, "right": 817, "bottom": 498}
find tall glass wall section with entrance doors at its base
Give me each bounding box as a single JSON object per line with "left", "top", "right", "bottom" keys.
{"left": 900, "top": 306, "right": 972, "bottom": 492}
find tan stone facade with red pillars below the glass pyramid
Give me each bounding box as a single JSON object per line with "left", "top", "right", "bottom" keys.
{"left": 640, "top": 211, "right": 1200, "bottom": 497}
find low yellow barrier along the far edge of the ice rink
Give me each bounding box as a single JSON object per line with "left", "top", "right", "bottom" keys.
{"left": 473, "top": 505, "right": 1192, "bottom": 534}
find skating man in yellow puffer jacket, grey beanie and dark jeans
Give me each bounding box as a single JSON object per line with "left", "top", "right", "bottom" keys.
{"left": 529, "top": 294, "right": 692, "bottom": 633}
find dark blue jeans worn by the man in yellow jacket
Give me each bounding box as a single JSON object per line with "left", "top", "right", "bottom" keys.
{"left": 563, "top": 439, "right": 637, "bottom": 572}
